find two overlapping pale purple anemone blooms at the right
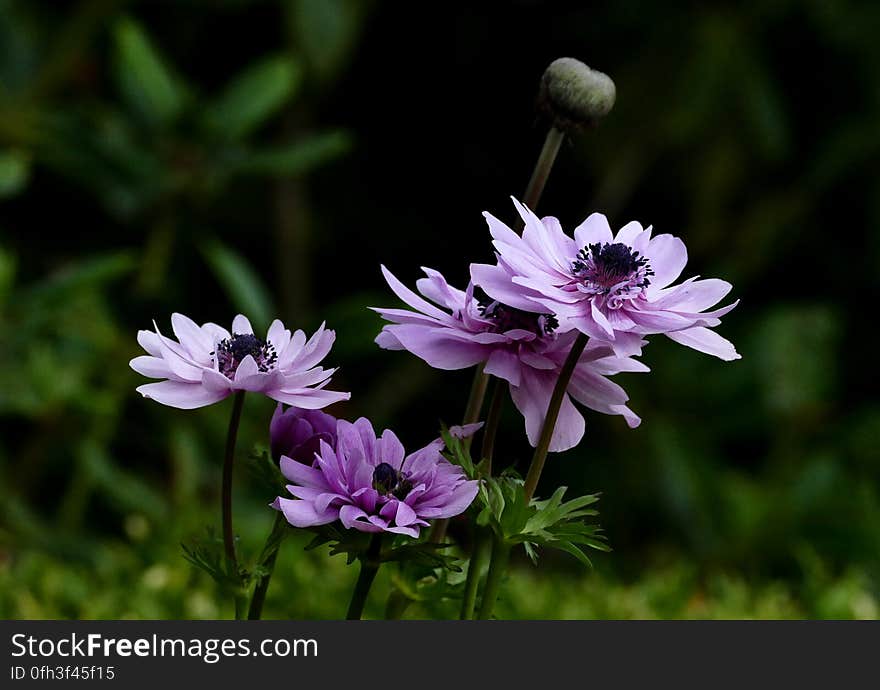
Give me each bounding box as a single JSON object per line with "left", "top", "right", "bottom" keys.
{"left": 376, "top": 195, "right": 739, "bottom": 452}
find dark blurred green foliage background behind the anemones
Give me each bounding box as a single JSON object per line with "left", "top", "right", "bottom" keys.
{"left": 0, "top": 0, "right": 880, "bottom": 618}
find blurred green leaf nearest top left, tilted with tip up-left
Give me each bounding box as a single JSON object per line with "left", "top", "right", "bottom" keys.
{"left": 113, "top": 18, "right": 186, "bottom": 126}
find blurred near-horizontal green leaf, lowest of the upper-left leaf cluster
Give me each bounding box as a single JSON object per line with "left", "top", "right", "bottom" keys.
{"left": 226, "top": 130, "right": 352, "bottom": 175}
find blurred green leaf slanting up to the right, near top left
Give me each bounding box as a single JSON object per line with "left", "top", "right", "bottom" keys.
{"left": 205, "top": 56, "right": 302, "bottom": 139}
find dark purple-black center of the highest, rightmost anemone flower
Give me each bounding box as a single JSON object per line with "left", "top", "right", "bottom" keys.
{"left": 571, "top": 242, "right": 654, "bottom": 309}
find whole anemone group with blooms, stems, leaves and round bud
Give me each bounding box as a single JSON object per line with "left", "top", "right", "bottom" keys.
{"left": 130, "top": 58, "right": 739, "bottom": 619}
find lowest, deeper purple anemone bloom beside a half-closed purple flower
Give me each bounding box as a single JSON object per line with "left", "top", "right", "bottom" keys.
{"left": 272, "top": 417, "right": 479, "bottom": 537}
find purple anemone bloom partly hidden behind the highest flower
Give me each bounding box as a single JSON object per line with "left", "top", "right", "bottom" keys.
{"left": 375, "top": 266, "right": 648, "bottom": 452}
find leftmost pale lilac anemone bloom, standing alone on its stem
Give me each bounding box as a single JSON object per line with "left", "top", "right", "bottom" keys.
{"left": 130, "top": 314, "right": 351, "bottom": 409}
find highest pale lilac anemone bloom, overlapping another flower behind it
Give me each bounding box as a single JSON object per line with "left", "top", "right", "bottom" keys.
{"left": 471, "top": 199, "right": 739, "bottom": 360}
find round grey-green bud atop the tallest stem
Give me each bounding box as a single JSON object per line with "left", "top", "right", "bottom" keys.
{"left": 538, "top": 58, "right": 617, "bottom": 131}
